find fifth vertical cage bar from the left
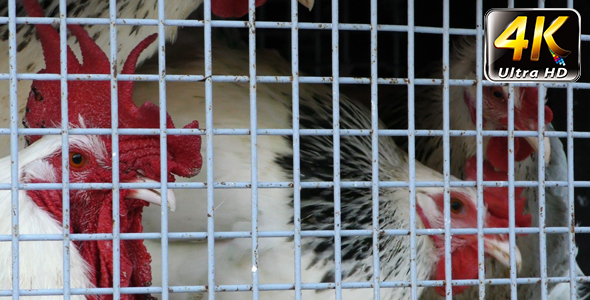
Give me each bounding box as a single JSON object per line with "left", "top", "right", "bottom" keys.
{"left": 203, "top": 0, "right": 215, "bottom": 300}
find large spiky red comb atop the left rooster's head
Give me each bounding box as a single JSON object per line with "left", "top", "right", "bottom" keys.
{"left": 23, "top": 0, "right": 202, "bottom": 177}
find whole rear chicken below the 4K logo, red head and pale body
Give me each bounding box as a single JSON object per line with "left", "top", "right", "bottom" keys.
{"left": 380, "top": 38, "right": 580, "bottom": 299}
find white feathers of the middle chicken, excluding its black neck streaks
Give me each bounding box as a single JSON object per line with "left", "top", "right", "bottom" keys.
{"left": 134, "top": 31, "right": 490, "bottom": 300}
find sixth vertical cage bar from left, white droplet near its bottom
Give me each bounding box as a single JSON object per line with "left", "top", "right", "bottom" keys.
{"left": 248, "top": 0, "right": 259, "bottom": 300}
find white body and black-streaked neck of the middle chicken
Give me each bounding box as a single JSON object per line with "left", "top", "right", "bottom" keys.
{"left": 134, "top": 29, "right": 518, "bottom": 299}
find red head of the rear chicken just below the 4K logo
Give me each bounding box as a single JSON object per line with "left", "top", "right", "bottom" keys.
{"left": 464, "top": 86, "right": 553, "bottom": 171}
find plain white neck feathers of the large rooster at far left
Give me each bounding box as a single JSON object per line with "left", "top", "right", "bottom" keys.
{"left": 0, "top": 136, "right": 93, "bottom": 300}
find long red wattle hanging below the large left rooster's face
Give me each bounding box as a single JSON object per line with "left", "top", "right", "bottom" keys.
{"left": 27, "top": 180, "right": 152, "bottom": 300}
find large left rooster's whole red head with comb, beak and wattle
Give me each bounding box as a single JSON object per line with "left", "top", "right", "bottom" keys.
{"left": 23, "top": 0, "right": 202, "bottom": 299}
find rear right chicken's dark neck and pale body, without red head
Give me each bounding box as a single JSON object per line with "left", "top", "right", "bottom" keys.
{"left": 380, "top": 39, "right": 580, "bottom": 300}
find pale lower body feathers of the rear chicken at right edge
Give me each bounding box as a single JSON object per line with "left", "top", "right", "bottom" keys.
{"left": 425, "top": 134, "right": 585, "bottom": 300}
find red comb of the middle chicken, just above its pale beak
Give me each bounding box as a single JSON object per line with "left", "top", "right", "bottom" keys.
{"left": 465, "top": 157, "right": 531, "bottom": 228}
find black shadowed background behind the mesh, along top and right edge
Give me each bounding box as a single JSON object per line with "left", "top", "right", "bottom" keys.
{"left": 204, "top": 0, "right": 590, "bottom": 274}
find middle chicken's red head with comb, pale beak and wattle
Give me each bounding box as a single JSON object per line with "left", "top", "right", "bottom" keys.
{"left": 418, "top": 158, "right": 531, "bottom": 296}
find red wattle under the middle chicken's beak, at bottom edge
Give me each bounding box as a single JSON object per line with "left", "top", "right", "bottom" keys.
{"left": 434, "top": 245, "right": 478, "bottom": 296}
